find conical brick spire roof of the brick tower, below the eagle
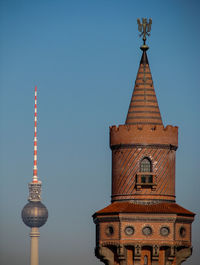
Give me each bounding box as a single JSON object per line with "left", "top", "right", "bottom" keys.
{"left": 125, "top": 46, "right": 163, "bottom": 125}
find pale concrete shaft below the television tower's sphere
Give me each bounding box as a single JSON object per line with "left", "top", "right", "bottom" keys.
{"left": 30, "top": 227, "right": 40, "bottom": 265}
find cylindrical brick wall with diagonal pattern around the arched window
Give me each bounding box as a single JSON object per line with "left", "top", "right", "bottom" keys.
{"left": 112, "top": 146, "right": 175, "bottom": 202}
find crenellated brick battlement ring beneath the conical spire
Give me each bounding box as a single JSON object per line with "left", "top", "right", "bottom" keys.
{"left": 110, "top": 124, "right": 178, "bottom": 148}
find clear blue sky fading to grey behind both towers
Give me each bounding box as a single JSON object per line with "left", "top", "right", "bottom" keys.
{"left": 0, "top": 0, "right": 200, "bottom": 265}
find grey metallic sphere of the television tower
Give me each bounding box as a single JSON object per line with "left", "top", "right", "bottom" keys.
{"left": 22, "top": 201, "right": 48, "bottom": 227}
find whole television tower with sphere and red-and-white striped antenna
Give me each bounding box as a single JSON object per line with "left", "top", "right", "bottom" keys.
{"left": 22, "top": 86, "right": 48, "bottom": 265}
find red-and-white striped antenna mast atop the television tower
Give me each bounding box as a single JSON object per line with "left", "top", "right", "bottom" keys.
{"left": 33, "top": 86, "right": 38, "bottom": 183}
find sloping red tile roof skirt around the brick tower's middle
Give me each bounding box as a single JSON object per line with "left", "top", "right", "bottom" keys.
{"left": 95, "top": 202, "right": 195, "bottom": 216}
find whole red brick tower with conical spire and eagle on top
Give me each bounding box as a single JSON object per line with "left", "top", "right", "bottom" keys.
{"left": 93, "top": 19, "right": 194, "bottom": 265}
